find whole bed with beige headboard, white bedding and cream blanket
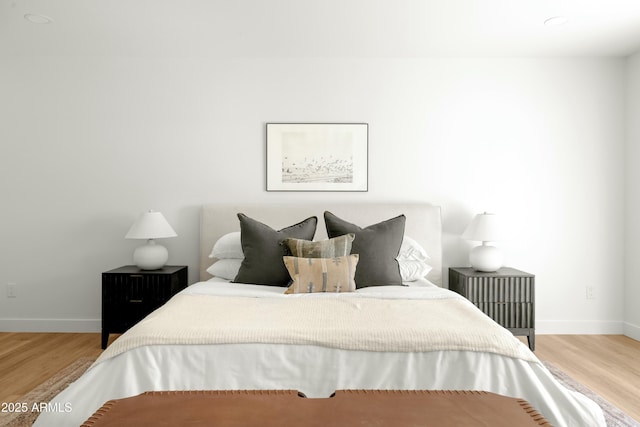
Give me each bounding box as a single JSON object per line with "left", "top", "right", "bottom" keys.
{"left": 35, "top": 204, "right": 605, "bottom": 426}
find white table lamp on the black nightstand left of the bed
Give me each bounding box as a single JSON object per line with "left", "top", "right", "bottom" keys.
{"left": 124, "top": 210, "right": 177, "bottom": 270}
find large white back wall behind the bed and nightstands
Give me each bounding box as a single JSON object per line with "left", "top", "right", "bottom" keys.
{"left": 0, "top": 57, "right": 626, "bottom": 333}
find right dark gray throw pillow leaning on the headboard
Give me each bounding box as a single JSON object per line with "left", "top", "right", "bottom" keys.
{"left": 324, "top": 211, "right": 406, "bottom": 288}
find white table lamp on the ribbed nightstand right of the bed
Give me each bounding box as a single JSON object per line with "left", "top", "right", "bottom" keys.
{"left": 462, "top": 212, "right": 505, "bottom": 272}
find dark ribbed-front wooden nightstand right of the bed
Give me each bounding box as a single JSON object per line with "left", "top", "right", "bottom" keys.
{"left": 449, "top": 267, "right": 536, "bottom": 350}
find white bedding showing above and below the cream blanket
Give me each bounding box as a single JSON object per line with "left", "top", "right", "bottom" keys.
{"left": 35, "top": 281, "right": 605, "bottom": 427}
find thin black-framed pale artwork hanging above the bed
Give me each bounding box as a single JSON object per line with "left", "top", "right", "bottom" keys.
{"left": 267, "top": 123, "right": 369, "bottom": 191}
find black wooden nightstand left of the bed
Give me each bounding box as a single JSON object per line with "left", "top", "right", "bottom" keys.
{"left": 102, "top": 265, "right": 188, "bottom": 348}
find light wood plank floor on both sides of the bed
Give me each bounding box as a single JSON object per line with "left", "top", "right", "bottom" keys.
{"left": 0, "top": 333, "right": 640, "bottom": 420}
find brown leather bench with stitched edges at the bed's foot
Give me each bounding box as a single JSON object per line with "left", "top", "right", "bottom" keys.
{"left": 82, "top": 390, "right": 551, "bottom": 427}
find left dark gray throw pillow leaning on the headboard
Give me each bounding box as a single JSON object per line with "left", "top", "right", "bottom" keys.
{"left": 233, "top": 213, "right": 318, "bottom": 286}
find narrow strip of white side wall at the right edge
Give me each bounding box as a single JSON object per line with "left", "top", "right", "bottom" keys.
{"left": 624, "top": 52, "right": 640, "bottom": 340}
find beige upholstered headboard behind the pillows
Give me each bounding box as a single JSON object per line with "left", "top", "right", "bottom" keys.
{"left": 200, "top": 203, "right": 442, "bottom": 286}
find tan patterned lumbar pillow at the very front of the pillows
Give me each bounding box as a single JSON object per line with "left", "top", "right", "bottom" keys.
{"left": 283, "top": 254, "right": 358, "bottom": 294}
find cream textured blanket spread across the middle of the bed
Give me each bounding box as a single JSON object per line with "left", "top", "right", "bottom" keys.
{"left": 96, "top": 294, "right": 537, "bottom": 364}
